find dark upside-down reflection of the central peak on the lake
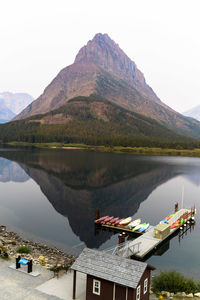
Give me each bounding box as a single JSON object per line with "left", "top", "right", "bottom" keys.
{"left": 0, "top": 151, "right": 179, "bottom": 248}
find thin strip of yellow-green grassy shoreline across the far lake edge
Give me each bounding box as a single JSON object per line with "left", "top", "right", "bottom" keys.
{"left": 2, "top": 142, "right": 200, "bottom": 157}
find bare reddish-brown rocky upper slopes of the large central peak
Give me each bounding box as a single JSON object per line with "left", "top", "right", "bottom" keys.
{"left": 15, "top": 33, "right": 200, "bottom": 138}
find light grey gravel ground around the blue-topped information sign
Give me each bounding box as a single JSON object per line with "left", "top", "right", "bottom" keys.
{"left": 0, "top": 259, "right": 60, "bottom": 300}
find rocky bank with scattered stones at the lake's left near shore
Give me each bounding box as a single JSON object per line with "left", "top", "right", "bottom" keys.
{"left": 0, "top": 225, "right": 75, "bottom": 269}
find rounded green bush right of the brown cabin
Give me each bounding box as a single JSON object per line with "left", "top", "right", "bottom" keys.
{"left": 152, "top": 271, "right": 200, "bottom": 293}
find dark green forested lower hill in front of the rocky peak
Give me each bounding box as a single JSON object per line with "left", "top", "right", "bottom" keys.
{"left": 0, "top": 97, "right": 199, "bottom": 149}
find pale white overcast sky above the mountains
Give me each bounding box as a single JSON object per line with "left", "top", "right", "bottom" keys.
{"left": 0, "top": 0, "right": 200, "bottom": 112}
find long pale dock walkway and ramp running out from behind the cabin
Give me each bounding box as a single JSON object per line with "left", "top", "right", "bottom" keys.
{"left": 101, "top": 207, "right": 196, "bottom": 260}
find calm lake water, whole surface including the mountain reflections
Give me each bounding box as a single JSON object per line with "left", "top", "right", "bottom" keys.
{"left": 0, "top": 148, "right": 200, "bottom": 279}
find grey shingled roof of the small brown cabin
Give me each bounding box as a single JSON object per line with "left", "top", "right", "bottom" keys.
{"left": 71, "top": 248, "right": 154, "bottom": 289}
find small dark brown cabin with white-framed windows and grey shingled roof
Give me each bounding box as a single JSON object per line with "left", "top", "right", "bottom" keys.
{"left": 72, "top": 248, "right": 155, "bottom": 300}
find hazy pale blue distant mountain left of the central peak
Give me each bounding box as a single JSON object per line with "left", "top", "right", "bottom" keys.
{"left": 0, "top": 92, "right": 34, "bottom": 123}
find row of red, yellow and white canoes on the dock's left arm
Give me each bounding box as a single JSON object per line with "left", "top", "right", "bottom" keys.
{"left": 96, "top": 216, "right": 149, "bottom": 232}
